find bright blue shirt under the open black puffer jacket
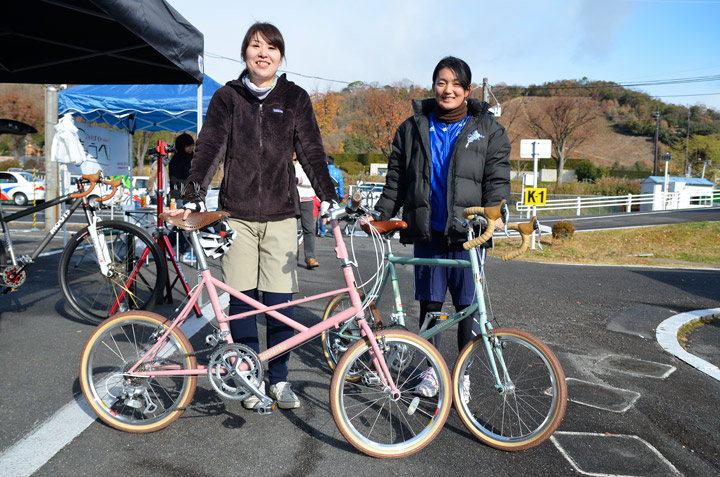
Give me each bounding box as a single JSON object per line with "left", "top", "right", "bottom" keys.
{"left": 429, "top": 113, "right": 469, "bottom": 232}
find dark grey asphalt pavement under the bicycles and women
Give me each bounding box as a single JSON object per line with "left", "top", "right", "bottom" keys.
{"left": 0, "top": 209, "right": 720, "bottom": 476}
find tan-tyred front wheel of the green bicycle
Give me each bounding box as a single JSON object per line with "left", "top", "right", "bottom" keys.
{"left": 453, "top": 328, "right": 567, "bottom": 451}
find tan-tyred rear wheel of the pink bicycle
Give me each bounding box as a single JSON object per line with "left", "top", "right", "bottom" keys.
{"left": 80, "top": 311, "right": 197, "bottom": 433}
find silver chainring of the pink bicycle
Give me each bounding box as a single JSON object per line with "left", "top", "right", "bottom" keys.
{"left": 208, "top": 344, "right": 263, "bottom": 400}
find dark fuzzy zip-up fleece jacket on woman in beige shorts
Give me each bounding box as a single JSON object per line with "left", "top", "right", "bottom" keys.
{"left": 185, "top": 73, "right": 338, "bottom": 222}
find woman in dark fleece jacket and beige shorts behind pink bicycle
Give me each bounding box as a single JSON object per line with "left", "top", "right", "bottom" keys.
{"left": 175, "top": 23, "right": 337, "bottom": 409}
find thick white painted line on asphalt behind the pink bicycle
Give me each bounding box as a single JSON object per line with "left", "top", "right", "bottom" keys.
{"left": 0, "top": 293, "right": 230, "bottom": 477}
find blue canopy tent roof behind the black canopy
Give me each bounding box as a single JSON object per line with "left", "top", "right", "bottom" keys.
{"left": 58, "top": 75, "right": 221, "bottom": 134}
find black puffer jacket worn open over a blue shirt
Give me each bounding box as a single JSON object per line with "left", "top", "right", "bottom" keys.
{"left": 375, "top": 99, "right": 510, "bottom": 243}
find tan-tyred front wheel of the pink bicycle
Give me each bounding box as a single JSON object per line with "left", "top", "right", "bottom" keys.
{"left": 330, "top": 330, "right": 452, "bottom": 458}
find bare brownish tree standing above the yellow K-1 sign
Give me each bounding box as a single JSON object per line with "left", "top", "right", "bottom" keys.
{"left": 525, "top": 96, "right": 598, "bottom": 184}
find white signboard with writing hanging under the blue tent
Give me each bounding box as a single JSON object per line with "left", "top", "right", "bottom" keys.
{"left": 68, "top": 123, "right": 130, "bottom": 176}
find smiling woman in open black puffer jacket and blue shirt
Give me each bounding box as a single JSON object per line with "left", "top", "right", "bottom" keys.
{"left": 369, "top": 56, "right": 510, "bottom": 400}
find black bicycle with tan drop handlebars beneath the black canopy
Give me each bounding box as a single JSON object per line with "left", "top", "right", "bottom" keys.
{"left": 0, "top": 172, "right": 167, "bottom": 324}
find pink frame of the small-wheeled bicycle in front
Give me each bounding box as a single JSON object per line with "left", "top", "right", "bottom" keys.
{"left": 128, "top": 219, "right": 399, "bottom": 396}
